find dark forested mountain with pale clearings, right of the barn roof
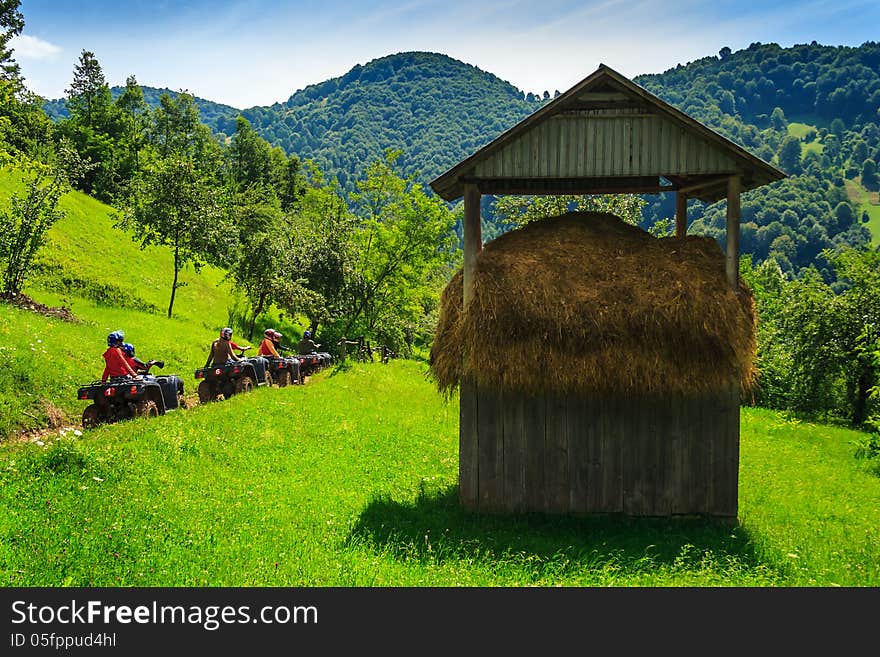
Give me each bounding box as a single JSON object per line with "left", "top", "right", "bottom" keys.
{"left": 635, "top": 42, "right": 880, "bottom": 281}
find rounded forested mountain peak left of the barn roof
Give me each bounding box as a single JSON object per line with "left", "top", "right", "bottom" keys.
{"left": 237, "top": 52, "right": 540, "bottom": 188}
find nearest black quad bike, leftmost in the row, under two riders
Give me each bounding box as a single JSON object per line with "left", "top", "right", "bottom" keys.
{"left": 77, "top": 361, "right": 186, "bottom": 429}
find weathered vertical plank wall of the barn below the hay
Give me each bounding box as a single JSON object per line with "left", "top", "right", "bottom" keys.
{"left": 459, "top": 382, "right": 739, "bottom": 518}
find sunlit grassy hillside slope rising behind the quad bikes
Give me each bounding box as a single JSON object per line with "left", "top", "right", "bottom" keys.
{"left": 0, "top": 169, "right": 232, "bottom": 439}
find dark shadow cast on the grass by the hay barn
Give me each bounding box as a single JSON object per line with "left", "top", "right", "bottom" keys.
{"left": 347, "top": 486, "right": 774, "bottom": 578}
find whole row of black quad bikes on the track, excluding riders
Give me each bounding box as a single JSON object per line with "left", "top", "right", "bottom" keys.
{"left": 77, "top": 336, "right": 332, "bottom": 429}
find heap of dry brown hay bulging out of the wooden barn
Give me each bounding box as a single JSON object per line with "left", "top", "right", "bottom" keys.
{"left": 431, "top": 212, "right": 756, "bottom": 394}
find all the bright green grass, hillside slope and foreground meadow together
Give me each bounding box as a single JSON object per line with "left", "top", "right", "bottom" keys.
{"left": 0, "top": 164, "right": 880, "bottom": 587}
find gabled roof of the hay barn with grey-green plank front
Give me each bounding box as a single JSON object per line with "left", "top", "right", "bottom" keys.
{"left": 431, "top": 64, "right": 786, "bottom": 202}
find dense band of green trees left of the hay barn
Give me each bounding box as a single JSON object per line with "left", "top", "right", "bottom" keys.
{"left": 0, "top": 0, "right": 458, "bottom": 354}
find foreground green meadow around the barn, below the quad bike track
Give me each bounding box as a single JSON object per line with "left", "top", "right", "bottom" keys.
{"left": 0, "top": 361, "right": 880, "bottom": 587}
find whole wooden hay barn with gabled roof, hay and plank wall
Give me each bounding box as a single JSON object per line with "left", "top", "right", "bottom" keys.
{"left": 431, "top": 65, "right": 785, "bottom": 518}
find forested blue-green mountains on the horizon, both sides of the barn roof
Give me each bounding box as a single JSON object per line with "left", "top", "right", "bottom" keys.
{"left": 41, "top": 42, "right": 880, "bottom": 281}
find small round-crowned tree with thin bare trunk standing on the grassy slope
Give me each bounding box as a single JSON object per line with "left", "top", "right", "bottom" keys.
{"left": 118, "top": 155, "right": 237, "bottom": 318}
